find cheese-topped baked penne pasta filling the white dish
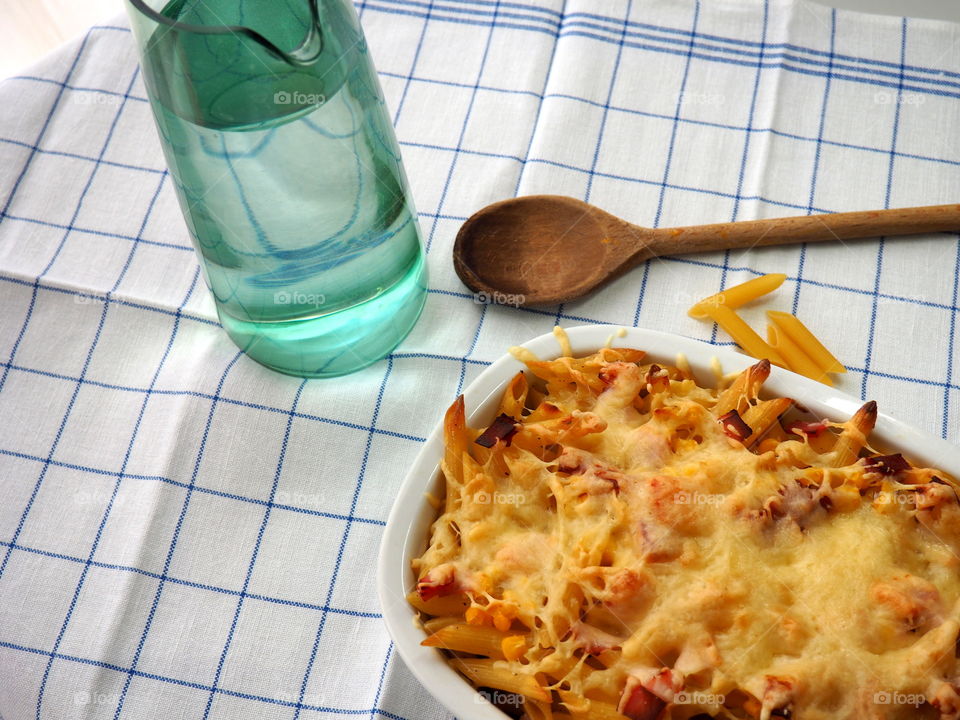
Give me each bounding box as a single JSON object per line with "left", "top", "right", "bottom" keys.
{"left": 409, "top": 348, "right": 960, "bottom": 720}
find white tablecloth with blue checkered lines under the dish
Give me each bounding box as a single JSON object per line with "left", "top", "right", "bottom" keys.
{"left": 0, "top": 0, "right": 960, "bottom": 720}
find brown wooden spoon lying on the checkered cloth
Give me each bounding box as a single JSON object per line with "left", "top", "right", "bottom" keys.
{"left": 453, "top": 195, "right": 960, "bottom": 305}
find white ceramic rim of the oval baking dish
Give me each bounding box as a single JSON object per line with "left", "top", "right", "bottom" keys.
{"left": 377, "top": 325, "right": 960, "bottom": 720}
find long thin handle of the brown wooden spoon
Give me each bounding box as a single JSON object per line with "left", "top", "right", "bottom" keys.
{"left": 648, "top": 205, "right": 960, "bottom": 254}
